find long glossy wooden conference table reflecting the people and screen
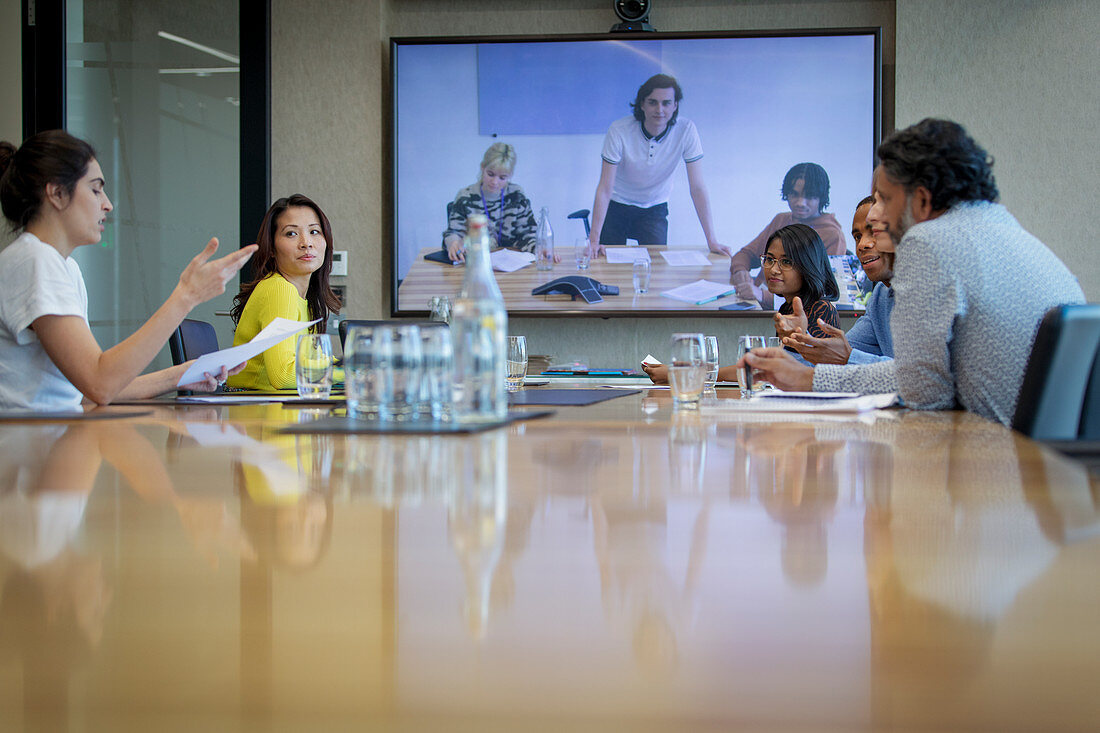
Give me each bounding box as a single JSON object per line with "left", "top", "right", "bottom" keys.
{"left": 0, "top": 389, "right": 1100, "bottom": 731}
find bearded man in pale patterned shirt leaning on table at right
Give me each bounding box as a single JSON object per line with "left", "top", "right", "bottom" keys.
{"left": 747, "top": 119, "right": 1085, "bottom": 425}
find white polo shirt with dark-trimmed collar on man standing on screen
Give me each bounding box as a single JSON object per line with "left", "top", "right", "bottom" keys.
{"left": 602, "top": 117, "right": 703, "bottom": 208}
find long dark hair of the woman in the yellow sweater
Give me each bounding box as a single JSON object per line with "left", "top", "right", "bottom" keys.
{"left": 230, "top": 194, "right": 340, "bottom": 333}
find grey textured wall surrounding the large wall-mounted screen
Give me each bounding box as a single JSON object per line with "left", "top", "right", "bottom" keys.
{"left": 272, "top": 0, "right": 894, "bottom": 365}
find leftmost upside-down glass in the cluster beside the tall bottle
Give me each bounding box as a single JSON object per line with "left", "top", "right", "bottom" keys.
{"left": 343, "top": 326, "right": 393, "bottom": 419}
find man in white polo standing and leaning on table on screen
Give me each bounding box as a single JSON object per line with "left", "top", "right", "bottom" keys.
{"left": 589, "top": 74, "right": 732, "bottom": 255}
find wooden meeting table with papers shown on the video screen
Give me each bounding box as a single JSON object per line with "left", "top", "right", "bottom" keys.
{"left": 397, "top": 247, "right": 760, "bottom": 315}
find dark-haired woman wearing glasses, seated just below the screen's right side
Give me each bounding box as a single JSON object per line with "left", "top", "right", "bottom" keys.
{"left": 760, "top": 223, "right": 840, "bottom": 338}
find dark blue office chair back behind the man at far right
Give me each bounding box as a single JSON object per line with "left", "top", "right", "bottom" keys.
{"left": 1012, "top": 304, "right": 1100, "bottom": 441}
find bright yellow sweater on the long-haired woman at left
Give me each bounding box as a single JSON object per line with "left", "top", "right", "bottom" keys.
{"left": 229, "top": 274, "right": 309, "bottom": 390}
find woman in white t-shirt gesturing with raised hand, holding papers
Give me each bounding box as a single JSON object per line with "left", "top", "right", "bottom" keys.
{"left": 0, "top": 130, "right": 256, "bottom": 411}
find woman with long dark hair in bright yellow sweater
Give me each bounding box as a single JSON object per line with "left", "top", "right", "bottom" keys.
{"left": 229, "top": 194, "right": 340, "bottom": 390}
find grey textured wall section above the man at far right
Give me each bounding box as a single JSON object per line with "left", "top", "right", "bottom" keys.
{"left": 897, "top": 0, "right": 1100, "bottom": 302}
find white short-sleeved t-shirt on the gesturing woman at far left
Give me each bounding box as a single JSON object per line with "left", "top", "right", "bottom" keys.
{"left": 0, "top": 232, "right": 88, "bottom": 411}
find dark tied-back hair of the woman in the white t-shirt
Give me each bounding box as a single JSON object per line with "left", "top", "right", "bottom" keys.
{"left": 0, "top": 130, "right": 96, "bottom": 230}
